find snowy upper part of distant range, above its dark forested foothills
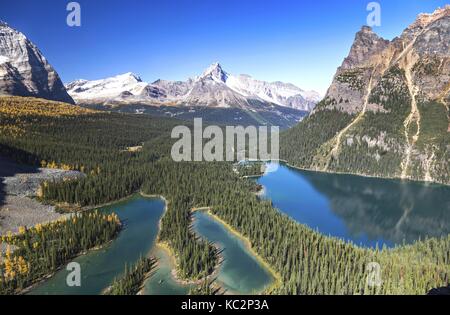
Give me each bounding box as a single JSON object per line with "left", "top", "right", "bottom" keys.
{"left": 66, "top": 63, "right": 321, "bottom": 111}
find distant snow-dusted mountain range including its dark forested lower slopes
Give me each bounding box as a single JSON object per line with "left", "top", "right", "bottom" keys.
{"left": 66, "top": 63, "right": 321, "bottom": 129}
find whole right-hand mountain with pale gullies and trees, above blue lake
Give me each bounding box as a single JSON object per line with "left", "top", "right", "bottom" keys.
{"left": 282, "top": 6, "right": 450, "bottom": 183}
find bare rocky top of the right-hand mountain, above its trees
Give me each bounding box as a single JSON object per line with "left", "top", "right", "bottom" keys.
{"left": 318, "top": 6, "right": 450, "bottom": 113}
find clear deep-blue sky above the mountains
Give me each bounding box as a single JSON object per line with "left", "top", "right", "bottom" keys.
{"left": 0, "top": 0, "right": 448, "bottom": 93}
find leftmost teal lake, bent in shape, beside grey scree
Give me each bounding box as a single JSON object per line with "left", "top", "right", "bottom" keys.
{"left": 30, "top": 196, "right": 164, "bottom": 295}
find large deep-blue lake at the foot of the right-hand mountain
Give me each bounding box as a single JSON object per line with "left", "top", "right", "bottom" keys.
{"left": 257, "top": 164, "right": 450, "bottom": 247}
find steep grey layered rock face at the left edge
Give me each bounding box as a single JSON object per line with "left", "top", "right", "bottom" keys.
{"left": 0, "top": 22, "right": 73, "bottom": 103}
